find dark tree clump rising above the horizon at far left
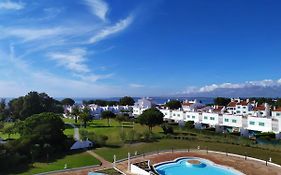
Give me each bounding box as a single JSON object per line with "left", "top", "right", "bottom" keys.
{"left": 9, "top": 92, "right": 63, "bottom": 120}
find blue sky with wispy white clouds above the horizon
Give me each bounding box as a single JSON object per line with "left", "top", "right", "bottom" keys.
{"left": 0, "top": 0, "right": 281, "bottom": 97}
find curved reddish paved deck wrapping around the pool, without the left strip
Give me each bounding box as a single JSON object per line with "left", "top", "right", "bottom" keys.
{"left": 117, "top": 152, "right": 281, "bottom": 175}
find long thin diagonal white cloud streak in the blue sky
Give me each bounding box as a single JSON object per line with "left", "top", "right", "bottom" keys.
{"left": 89, "top": 16, "right": 133, "bottom": 44}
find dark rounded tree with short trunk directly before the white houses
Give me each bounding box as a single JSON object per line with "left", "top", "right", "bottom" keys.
{"left": 138, "top": 108, "right": 164, "bottom": 132}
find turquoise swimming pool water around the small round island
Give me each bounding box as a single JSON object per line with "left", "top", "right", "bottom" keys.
{"left": 155, "top": 158, "right": 242, "bottom": 175}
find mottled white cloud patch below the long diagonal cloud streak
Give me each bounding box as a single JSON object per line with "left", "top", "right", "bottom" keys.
{"left": 48, "top": 48, "right": 90, "bottom": 73}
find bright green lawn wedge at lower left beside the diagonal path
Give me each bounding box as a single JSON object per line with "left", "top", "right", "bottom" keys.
{"left": 18, "top": 152, "right": 100, "bottom": 175}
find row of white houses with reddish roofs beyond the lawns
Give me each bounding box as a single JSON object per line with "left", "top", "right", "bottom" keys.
{"left": 65, "top": 98, "right": 281, "bottom": 137}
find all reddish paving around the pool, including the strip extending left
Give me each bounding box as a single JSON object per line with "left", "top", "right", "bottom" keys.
{"left": 47, "top": 151, "right": 281, "bottom": 175}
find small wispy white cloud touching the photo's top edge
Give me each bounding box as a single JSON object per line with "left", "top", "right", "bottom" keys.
{"left": 84, "top": 0, "right": 108, "bottom": 21}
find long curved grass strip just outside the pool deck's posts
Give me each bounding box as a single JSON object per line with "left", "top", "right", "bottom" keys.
{"left": 95, "top": 139, "right": 281, "bottom": 164}
